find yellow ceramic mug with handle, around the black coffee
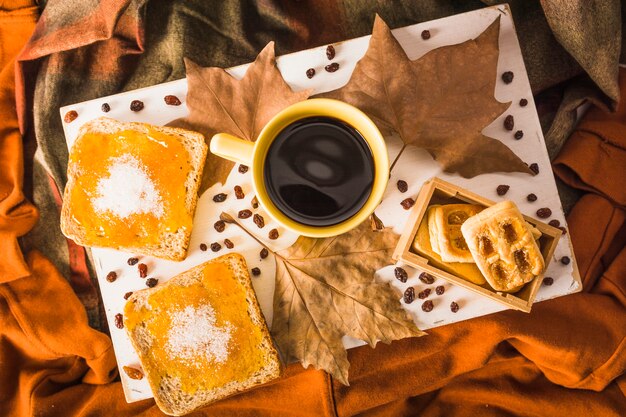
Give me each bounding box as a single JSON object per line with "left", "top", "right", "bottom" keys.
{"left": 210, "top": 98, "right": 389, "bottom": 237}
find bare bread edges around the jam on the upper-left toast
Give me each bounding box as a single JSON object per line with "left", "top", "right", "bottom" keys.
{"left": 61, "top": 117, "right": 208, "bottom": 261}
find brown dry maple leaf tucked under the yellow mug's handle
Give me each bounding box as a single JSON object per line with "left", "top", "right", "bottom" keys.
{"left": 169, "top": 42, "right": 310, "bottom": 194}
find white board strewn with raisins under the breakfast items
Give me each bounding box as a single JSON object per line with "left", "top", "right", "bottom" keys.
{"left": 60, "top": 5, "right": 581, "bottom": 402}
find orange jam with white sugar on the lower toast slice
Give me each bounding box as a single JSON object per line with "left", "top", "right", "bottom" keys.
{"left": 124, "top": 263, "right": 265, "bottom": 394}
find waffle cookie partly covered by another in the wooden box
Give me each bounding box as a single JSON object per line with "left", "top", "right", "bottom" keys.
{"left": 427, "top": 204, "right": 484, "bottom": 263}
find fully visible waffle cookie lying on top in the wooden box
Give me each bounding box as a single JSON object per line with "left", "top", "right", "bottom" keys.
{"left": 461, "top": 201, "right": 545, "bottom": 292}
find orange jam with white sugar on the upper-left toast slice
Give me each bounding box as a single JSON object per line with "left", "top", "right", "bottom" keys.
{"left": 69, "top": 130, "right": 193, "bottom": 247}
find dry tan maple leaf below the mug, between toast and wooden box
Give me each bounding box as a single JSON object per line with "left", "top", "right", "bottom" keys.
{"left": 220, "top": 213, "right": 425, "bottom": 385}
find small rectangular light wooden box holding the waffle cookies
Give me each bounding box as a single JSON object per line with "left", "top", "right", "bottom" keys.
{"left": 393, "top": 177, "right": 562, "bottom": 313}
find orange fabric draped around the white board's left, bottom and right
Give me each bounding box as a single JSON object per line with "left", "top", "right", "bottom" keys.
{"left": 0, "top": 2, "right": 626, "bottom": 417}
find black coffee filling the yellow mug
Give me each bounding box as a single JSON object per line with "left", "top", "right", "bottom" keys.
{"left": 263, "top": 117, "right": 374, "bottom": 226}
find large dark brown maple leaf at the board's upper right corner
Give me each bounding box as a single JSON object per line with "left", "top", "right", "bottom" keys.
{"left": 323, "top": 16, "right": 532, "bottom": 178}
